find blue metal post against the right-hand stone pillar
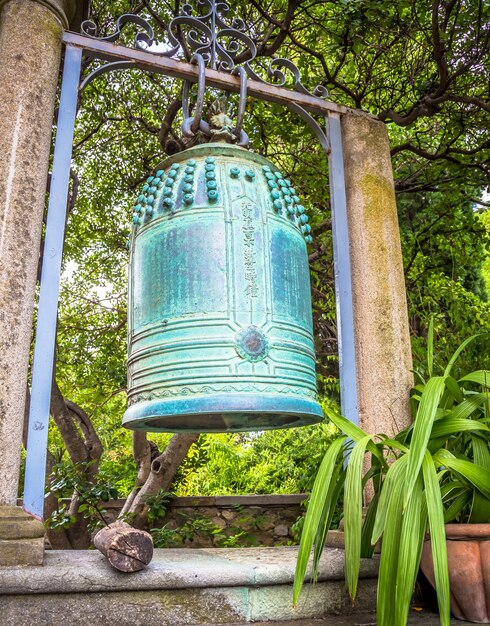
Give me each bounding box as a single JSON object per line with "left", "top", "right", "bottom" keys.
{"left": 327, "top": 113, "right": 359, "bottom": 424}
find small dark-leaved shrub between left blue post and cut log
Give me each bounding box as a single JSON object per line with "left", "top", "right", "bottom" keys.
{"left": 45, "top": 462, "right": 119, "bottom": 530}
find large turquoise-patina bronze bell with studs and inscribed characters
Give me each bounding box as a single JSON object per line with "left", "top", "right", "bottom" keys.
{"left": 123, "top": 143, "right": 322, "bottom": 432}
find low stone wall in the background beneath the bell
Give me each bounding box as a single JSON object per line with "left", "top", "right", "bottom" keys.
{"left": 104, "top": 494, "right": 307, "bottom": 548}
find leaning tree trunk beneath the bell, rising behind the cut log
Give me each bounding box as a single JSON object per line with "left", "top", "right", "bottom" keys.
{"left": 121, "top": 433, "right": 199, "bottom": 528}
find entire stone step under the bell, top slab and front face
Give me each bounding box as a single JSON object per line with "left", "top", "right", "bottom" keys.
{"left": 0, "top": 547, "right": 378, "bottom": 626}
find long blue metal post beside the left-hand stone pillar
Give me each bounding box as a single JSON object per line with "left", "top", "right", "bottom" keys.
{"left": 24, "top": 46, "right": 82, "bottom": 519}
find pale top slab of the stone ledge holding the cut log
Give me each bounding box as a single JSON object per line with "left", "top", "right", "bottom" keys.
{"left": 0, "top": 547, "right": 378, "bottom": 595}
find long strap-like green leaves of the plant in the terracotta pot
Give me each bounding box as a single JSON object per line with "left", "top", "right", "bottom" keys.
{"left": 293, "top": 324, "right": 490, "bottom": 626}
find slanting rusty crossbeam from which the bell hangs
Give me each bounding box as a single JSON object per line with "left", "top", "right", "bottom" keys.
{"left": 63, "top": 32, "right": 353, "bottom": 116}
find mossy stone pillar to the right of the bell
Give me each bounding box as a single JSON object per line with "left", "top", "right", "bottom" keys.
{"left": 342, "top": 114, "right": 413, "bottom": 435}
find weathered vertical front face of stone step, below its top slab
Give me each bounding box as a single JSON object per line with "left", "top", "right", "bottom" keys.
{"left": 0, "top": 580, "right": 376, "bottom": 626}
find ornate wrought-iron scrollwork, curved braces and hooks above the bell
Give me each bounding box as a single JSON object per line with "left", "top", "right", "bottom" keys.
{"left": 80, "top": 0, "right": 330, "bottom": 153}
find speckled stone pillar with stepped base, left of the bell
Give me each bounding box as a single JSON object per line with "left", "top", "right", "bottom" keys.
{"left": 0, "top": 0, "right": 76, "bottom": 565}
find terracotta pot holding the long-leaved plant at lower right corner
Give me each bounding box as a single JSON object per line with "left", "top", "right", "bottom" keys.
{"left": 420, "top": 524, "right": 490, "bottom": 624}
